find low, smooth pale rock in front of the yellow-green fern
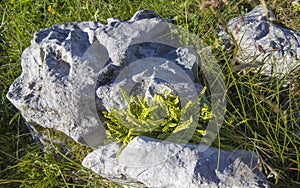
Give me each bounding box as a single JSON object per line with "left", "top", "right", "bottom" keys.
{"left": 82, "top": 137, "right": 269, "bottom": 188}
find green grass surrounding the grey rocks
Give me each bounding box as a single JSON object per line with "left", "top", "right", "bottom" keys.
{"left": 0, "top": 0, "right": 300, "bottom": 187}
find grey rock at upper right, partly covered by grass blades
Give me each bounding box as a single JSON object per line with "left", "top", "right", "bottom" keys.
{"left": 219, "top": 5, "right": 300, "bottom": 78}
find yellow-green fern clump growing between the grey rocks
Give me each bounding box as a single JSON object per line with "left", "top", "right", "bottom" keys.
{"left": 103, "top": 88, "right": 212, "bottom": 146}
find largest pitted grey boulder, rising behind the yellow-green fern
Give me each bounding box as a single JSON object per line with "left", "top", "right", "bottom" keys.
{"left": 7, "top": 11, "right": 202, "bottom": 147}
